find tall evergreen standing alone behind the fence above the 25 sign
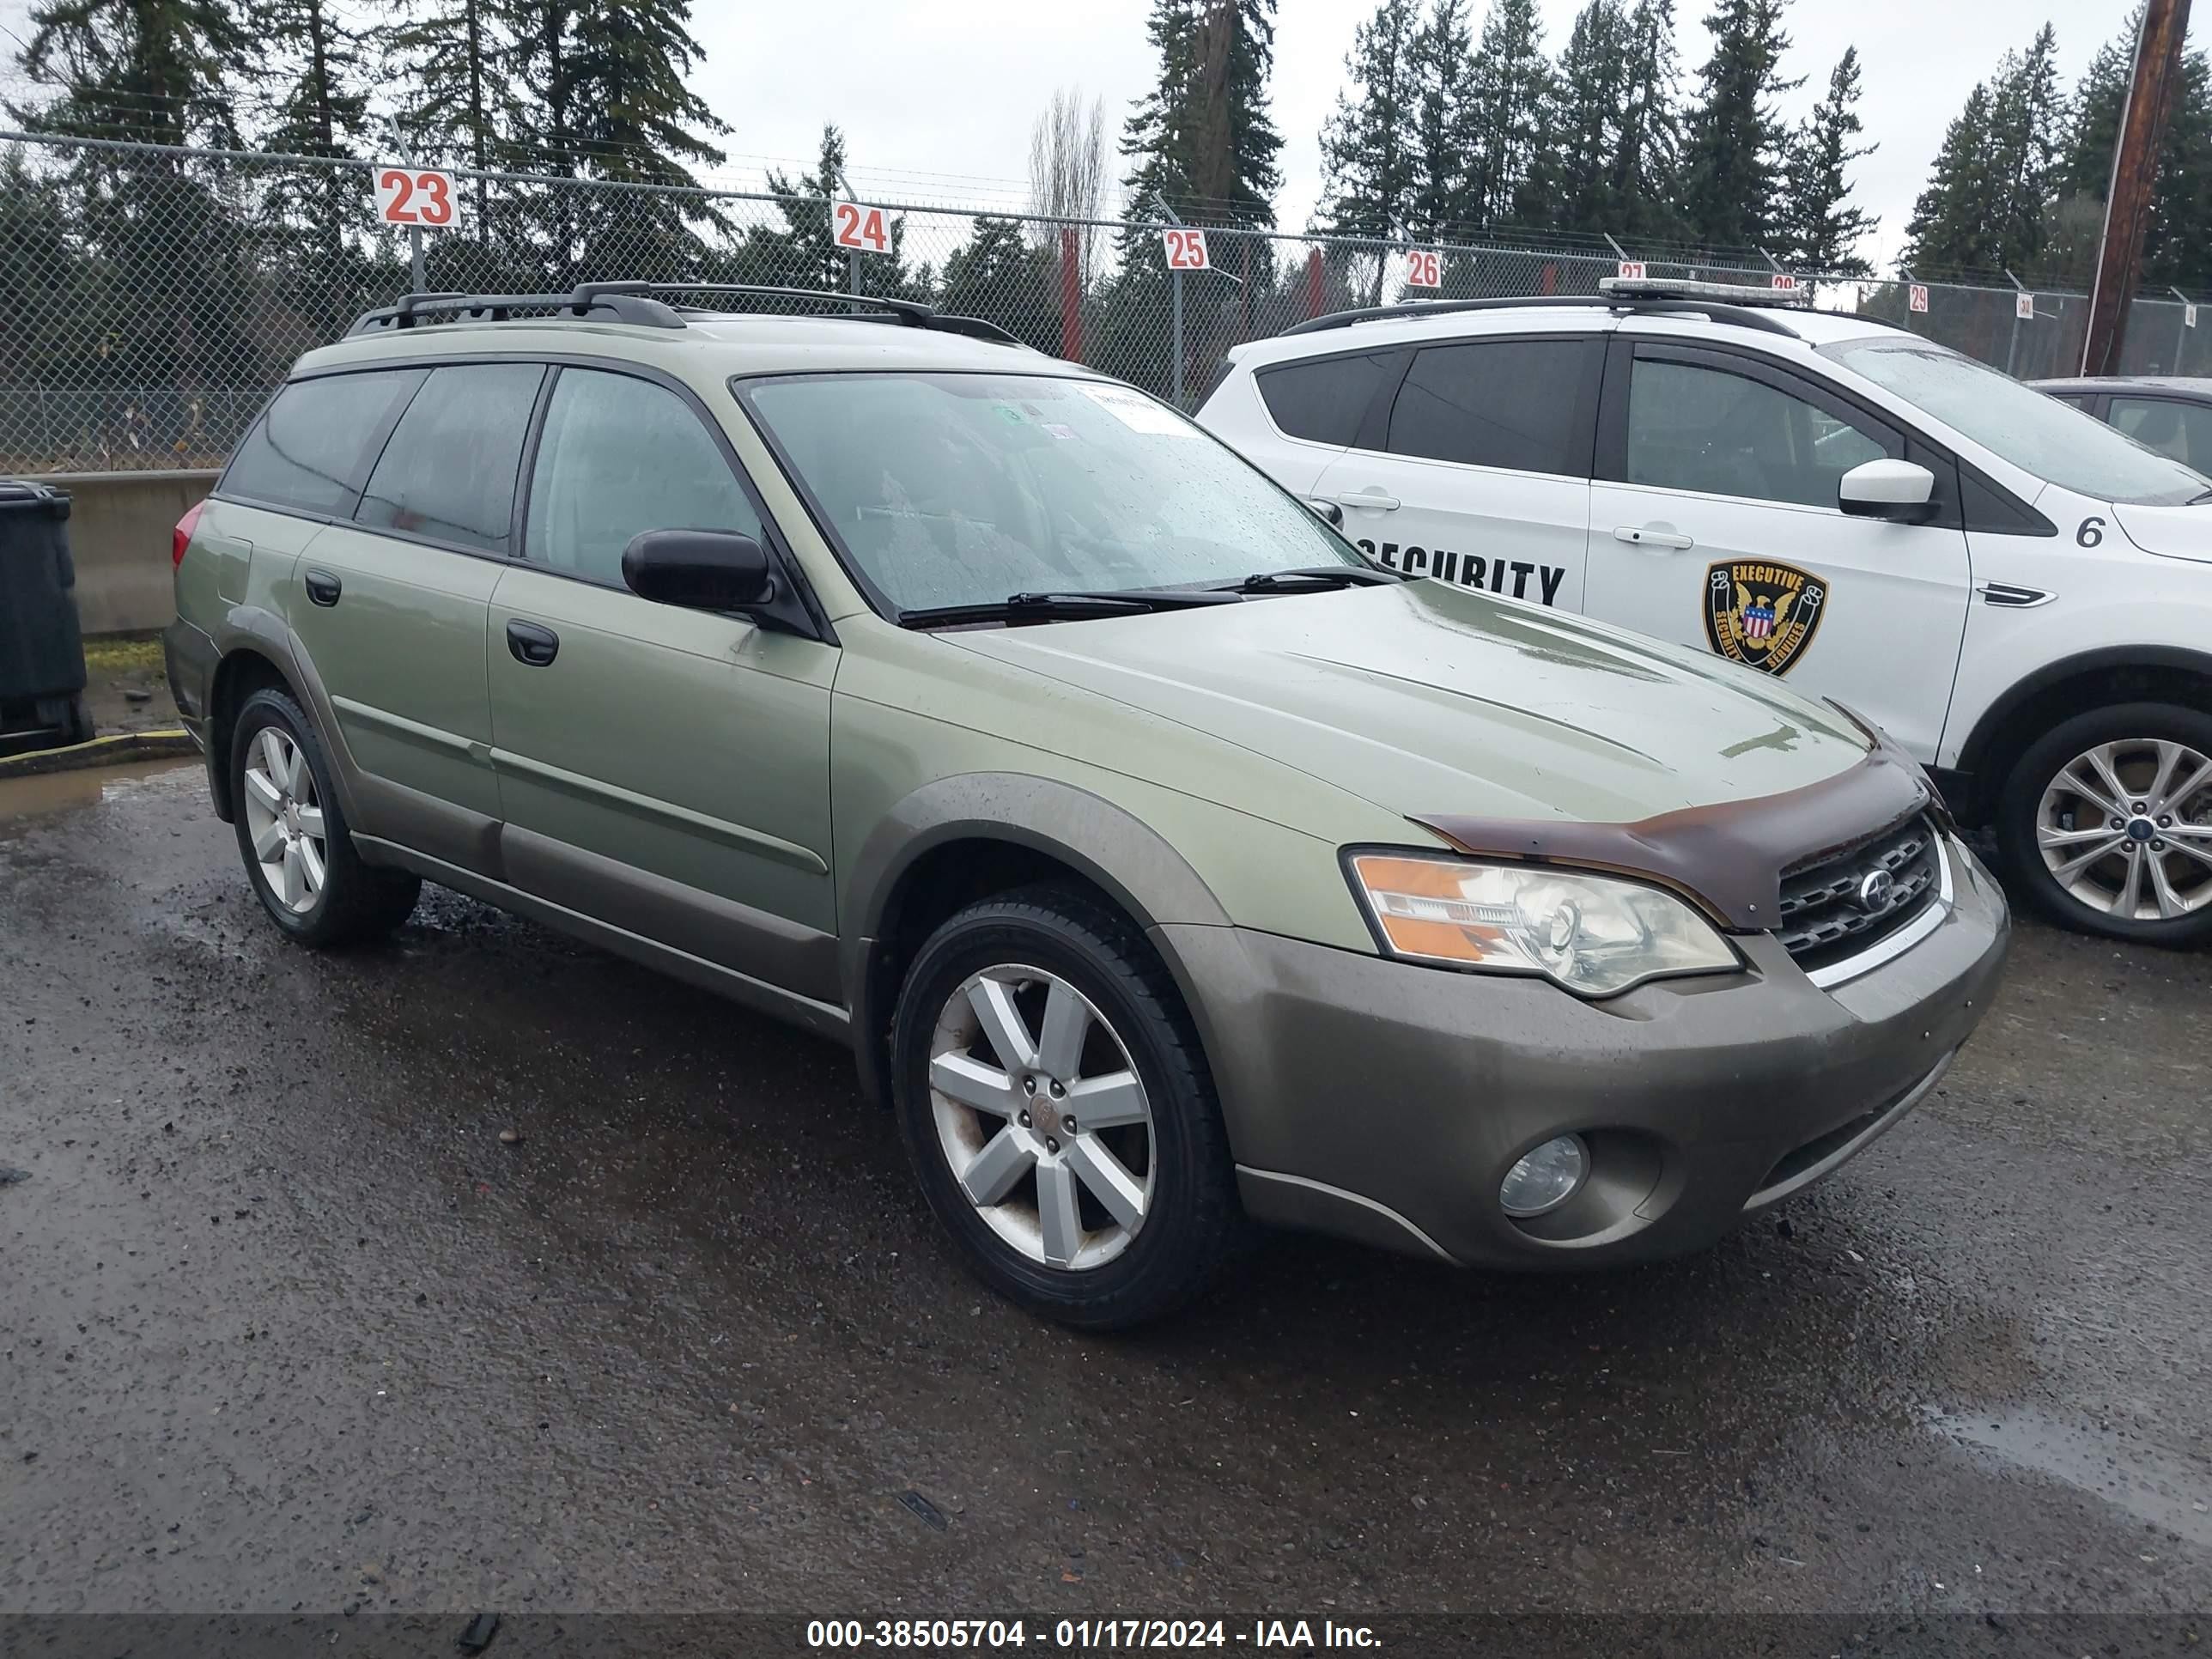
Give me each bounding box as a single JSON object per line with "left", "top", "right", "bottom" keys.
{"left": 1121, "top": 0, "right": 1283, "bottom": 241}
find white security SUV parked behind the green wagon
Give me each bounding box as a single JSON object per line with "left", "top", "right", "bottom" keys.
{"left": 1199, "top": 283, "right": 2212, "bottom": 945}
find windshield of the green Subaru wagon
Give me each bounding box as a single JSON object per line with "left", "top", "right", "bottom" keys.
{"left": 737, "top": 374, "right": 1364, "bottom": 611}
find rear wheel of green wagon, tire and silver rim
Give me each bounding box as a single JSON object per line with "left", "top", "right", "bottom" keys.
{"left": 230, "top": 690, "right": 422, "bottom": 947}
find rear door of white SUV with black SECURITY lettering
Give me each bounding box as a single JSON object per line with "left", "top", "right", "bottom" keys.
{"left": 1300, "top": 334, "right": 1604, "bottom": 611}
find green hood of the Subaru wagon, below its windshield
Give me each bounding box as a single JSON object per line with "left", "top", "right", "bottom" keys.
{"left": 940, "top": 581, "right": 1867, "bottom": 823}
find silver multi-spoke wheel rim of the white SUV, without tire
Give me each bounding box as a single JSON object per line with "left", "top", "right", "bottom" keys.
{"left": 2035, "top": 737, "right": 2212, "bottom": 922}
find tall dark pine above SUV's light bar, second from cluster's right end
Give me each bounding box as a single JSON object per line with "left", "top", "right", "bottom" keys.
{"left": 1681, "top": 0, "right": 1802, "bottom": 248}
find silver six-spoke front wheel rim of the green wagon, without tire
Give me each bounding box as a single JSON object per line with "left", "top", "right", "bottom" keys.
{"left": 929, "top": 964, "right": 1157, "bottom": 1270}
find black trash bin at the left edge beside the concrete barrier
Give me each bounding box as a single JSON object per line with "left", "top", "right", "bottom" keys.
{"left": 0, "top": 477, "right": 93, "bottom": 754}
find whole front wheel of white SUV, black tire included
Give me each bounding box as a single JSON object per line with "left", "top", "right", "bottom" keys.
{"left": 1997, "top": 703, "right": 2212, "bottom": 947}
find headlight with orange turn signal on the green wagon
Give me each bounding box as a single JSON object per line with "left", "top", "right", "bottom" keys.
{"left": 1349, "top": 852, "right": 1743, "bottom": 995}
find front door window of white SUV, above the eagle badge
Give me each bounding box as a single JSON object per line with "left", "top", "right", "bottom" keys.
{"left": 1626, "top": 358, "right": 1905, "bottom": 507}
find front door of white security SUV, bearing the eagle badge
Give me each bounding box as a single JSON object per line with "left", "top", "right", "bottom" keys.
{"left": 1586, "top": 334, "right": 1971, "bottom": 763}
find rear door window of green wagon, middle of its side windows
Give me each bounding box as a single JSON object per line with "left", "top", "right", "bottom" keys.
{"left": 354, "top": 362, "right": 544, "bottom": 553}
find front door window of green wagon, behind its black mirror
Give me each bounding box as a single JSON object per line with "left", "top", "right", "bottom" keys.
{"left": 525, "top": 369, "right": 761, "bottom": 588}
